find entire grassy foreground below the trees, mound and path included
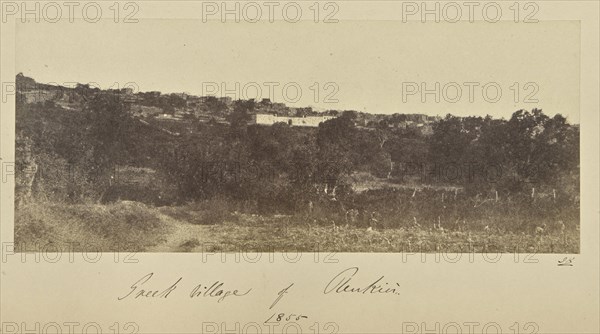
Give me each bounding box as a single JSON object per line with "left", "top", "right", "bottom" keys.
{"left": 15, "top": 201, "right": 579, "bottom": 253}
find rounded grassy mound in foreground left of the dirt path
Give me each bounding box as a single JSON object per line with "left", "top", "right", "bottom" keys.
{"left": 15, "top": 202, "right": 170, "bottom": 252}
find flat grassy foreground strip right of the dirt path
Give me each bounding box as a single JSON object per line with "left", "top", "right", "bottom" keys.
{"left": 157, "top": 210, "right": 579, "bottom": 253}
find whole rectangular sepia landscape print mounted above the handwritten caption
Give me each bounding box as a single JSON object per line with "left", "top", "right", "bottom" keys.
{"left": 14, "top": 20, "right": 580, "bottom": 254}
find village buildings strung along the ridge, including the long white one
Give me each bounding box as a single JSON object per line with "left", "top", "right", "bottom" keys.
{"left": 16, "top": 73, "right": 441, "bottom": 135}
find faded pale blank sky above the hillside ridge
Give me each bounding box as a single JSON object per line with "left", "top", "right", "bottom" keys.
{"left": 16, "top": 19, "right": 580, "bottom": 123}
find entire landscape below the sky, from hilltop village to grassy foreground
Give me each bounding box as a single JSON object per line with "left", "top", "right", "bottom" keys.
{"left": 15, "top": 74, "right": 580, "bottom": 253}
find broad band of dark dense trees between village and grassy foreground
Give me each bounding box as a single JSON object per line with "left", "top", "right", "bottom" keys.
{"left": 17, "top": 87, "right": 579, "bottom": 211}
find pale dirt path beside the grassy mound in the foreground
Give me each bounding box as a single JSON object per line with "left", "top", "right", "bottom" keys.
{"left": 146, "top": 213, "right": 213, "bottom": 253}
